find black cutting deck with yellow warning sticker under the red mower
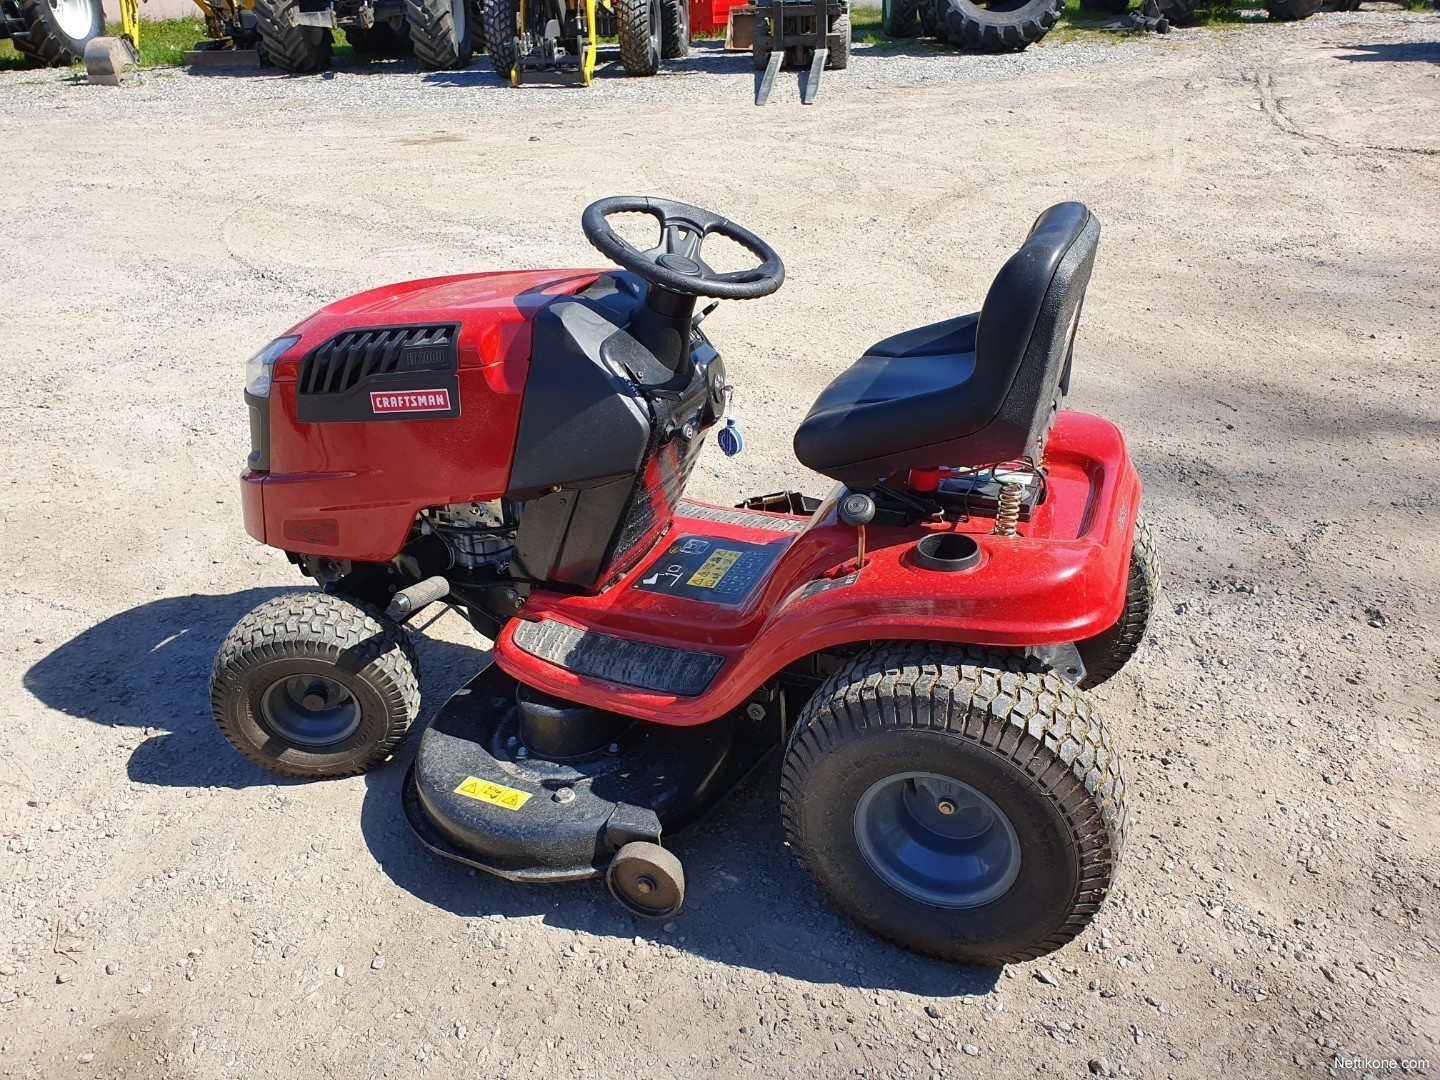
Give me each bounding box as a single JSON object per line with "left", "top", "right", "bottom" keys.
{"left": 403, "top": 665, "right": 779, "bottom": 881}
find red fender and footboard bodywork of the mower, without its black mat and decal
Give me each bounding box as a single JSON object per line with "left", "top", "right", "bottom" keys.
{"left": 494, "top": 412, "right": 1140, "bottom": 726}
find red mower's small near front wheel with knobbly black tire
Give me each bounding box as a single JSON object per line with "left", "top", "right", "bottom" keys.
{"left": 210, "top": 592, "right": 420, "bottom": 779}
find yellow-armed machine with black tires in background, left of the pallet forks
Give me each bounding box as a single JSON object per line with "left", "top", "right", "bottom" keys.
{"left": 480, "top": 0, "right": 690, "bottom": 86}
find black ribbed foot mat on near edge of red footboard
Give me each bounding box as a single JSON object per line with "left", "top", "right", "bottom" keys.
{"left": 511, "top": 619, "right": 724, "bottom": 697}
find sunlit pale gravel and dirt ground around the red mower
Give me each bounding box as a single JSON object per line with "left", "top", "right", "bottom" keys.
{"left": 0, "top": 9, "right": 1440, "bottom": 1077}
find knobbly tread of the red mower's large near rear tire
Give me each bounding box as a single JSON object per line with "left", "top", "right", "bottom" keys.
{"left": 780, "top": 642, "right": 1128, "bottom": 963}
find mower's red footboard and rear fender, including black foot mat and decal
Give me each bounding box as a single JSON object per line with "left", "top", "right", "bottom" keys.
{"left": 494, "top": 412, "right": 1140, "bottom": 724}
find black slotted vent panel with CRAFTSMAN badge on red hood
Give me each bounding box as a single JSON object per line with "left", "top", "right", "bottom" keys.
{"left": 295, "top": 323, "right": 459, "bottom": 423}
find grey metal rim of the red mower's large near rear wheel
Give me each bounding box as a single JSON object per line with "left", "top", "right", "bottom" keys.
{"left": 855, "top": 772, "right": 1021, "bottom": 909}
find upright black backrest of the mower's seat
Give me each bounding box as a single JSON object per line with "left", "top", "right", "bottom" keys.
{"left": 975, "top": 203, "right": 1100, "bottom": 462}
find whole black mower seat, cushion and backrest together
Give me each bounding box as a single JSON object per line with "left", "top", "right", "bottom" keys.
{"left": 795, "top": 203, "right": 1100, "bottom": 490}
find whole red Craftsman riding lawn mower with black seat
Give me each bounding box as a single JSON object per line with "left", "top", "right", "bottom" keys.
{"left": 212, "top": 197, "right": 1156, "bottom": 963}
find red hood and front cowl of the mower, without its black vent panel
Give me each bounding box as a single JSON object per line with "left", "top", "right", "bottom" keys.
{"left": 240, "top": 269, "right": 600, "bottom": 562}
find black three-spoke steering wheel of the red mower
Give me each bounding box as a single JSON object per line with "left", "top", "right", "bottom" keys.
{"left": 580, "top": 194, "right": 785, "bottom": 300}
